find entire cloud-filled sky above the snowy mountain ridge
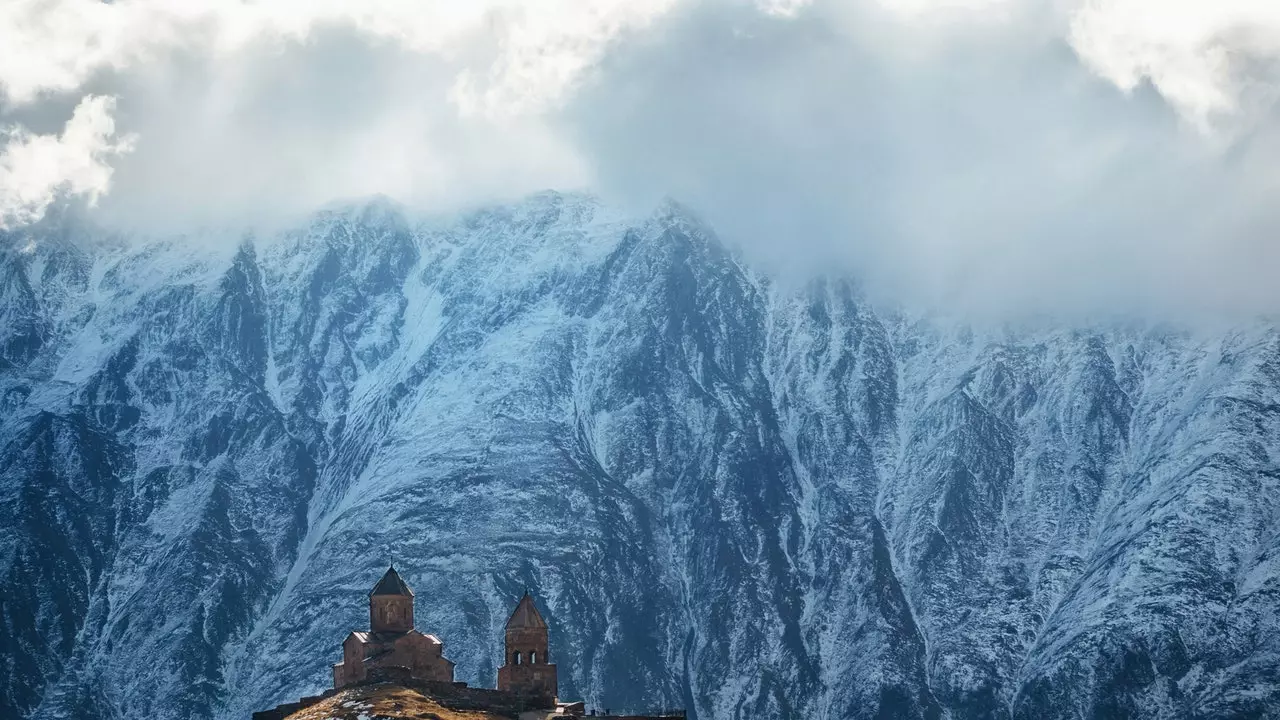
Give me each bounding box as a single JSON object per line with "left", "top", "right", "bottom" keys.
{"left": 0, "top": 0, "right": 1280, "bottom": 313}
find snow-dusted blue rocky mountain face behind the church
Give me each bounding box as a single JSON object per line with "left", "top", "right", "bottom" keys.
{"left": 0, "top": 193, "right": 1280, "bottom": 720}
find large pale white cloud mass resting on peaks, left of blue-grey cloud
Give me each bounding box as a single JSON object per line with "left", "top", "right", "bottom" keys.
{"left": 0, "top": 0, "right": 676, "bottom": 227}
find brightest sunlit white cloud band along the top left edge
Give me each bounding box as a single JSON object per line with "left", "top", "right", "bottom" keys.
{"left": 0, "top": 0, "right": 676, "bottom": 110}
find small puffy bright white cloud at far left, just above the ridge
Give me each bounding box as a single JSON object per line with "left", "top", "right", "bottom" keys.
{"left": 0, "top": 95, "right": 133, "bottom": 229}
